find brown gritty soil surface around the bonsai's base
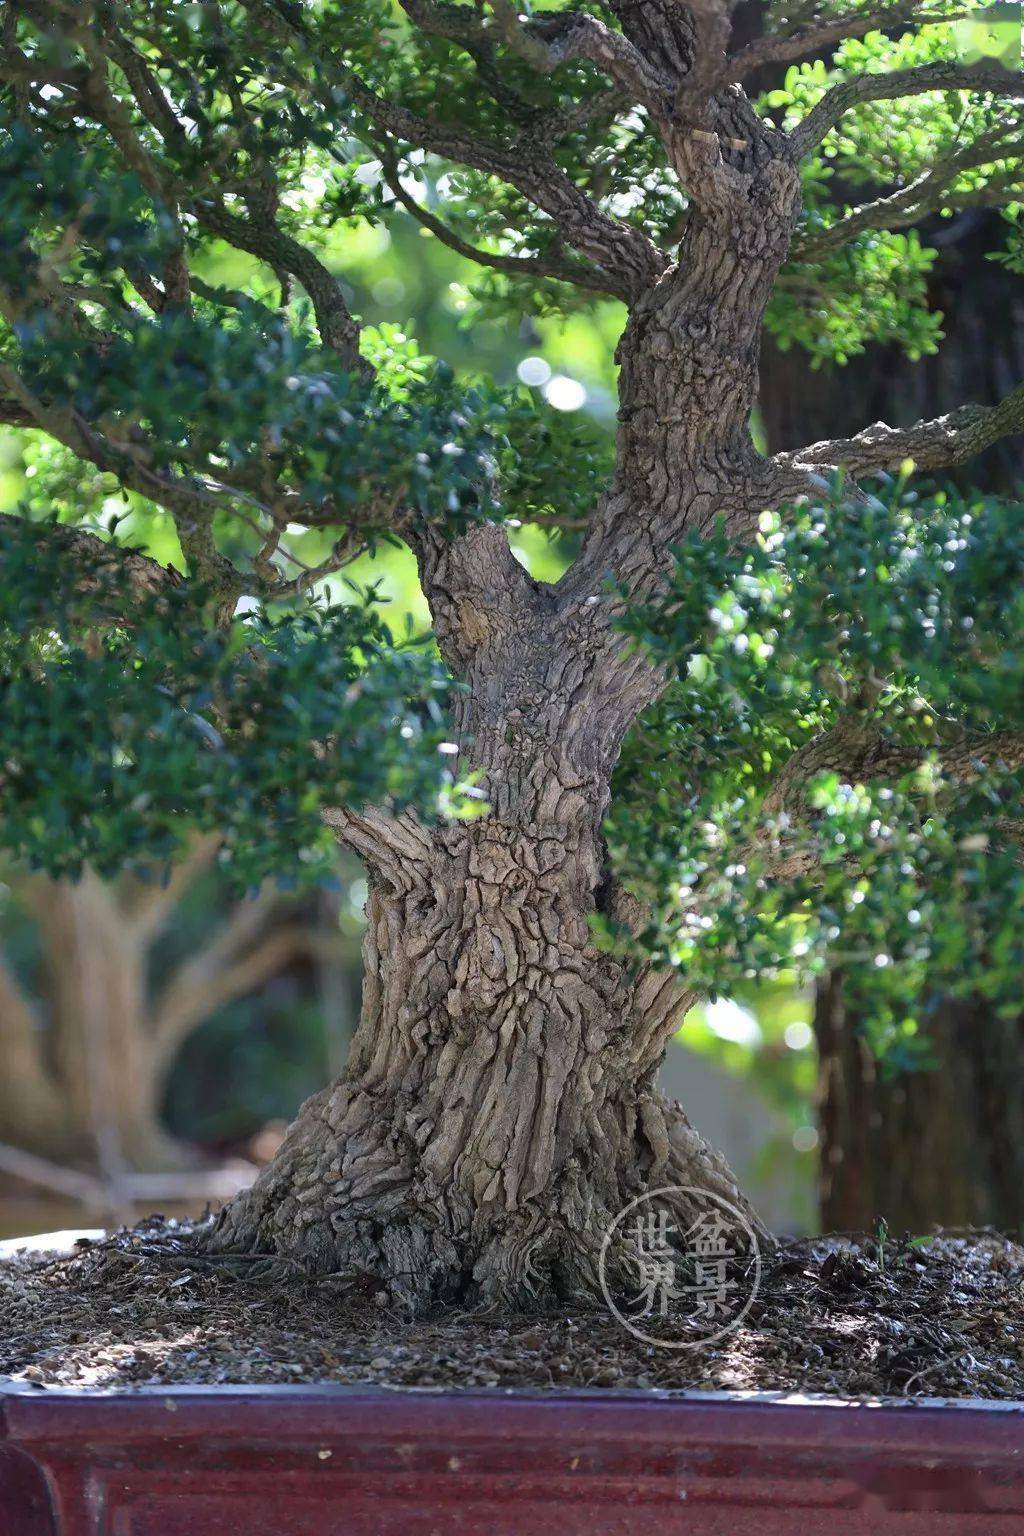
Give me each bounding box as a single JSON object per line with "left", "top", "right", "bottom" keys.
{"left": 0, "top": 1218, "right": 1024, "bottom": 1398}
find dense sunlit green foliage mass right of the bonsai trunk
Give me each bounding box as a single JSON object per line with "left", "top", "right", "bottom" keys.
{"left": 611, "top": 487, "right": 1024, "bottom": 1061}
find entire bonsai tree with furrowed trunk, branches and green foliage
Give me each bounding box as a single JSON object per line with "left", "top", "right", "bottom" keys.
{"left": 0, "top": 0, "right": 1024, "bottom": 1304}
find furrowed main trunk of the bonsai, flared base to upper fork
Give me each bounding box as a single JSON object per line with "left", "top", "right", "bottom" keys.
{"left": 212, "top": 135, "right": 798, "bottom": 1303}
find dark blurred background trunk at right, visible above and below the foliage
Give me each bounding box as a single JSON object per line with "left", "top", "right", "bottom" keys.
{"left": 743, "top": 3, "right": 1024, "bottom": 1230}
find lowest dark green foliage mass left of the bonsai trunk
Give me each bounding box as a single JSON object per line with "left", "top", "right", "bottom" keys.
{"left": 0, "top": 522, "right": 447, "bottom": 885}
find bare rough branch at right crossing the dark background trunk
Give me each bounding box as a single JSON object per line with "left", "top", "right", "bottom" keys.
{"left": 772, "top": 384, "right": 1024, "bottom": 479}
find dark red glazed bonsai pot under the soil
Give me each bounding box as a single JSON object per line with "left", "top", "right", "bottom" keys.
{"left": 0, "top": 1384, "right": 1024, "bottom": 1536}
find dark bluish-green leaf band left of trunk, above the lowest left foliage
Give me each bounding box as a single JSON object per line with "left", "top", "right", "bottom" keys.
{"left": 15, "top": 303, "right": 504, "bottom": 527}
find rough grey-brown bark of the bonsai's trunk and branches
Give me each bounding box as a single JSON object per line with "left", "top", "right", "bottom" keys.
{"left": 10, "top": 0, "right": 1024, "bottom": 1299}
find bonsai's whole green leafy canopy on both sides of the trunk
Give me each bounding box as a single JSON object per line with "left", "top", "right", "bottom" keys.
{"left": 0, "top": 0, "right": 1024, "bottom": 1038}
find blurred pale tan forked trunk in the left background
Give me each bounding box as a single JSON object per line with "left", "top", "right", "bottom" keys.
{"left": 0, "top": 839, "right": 310, "bottom": 1178}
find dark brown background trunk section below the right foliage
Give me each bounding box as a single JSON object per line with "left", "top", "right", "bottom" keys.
{"left": 815, "top": 977, "right": 1024, "bottom": 1233}
